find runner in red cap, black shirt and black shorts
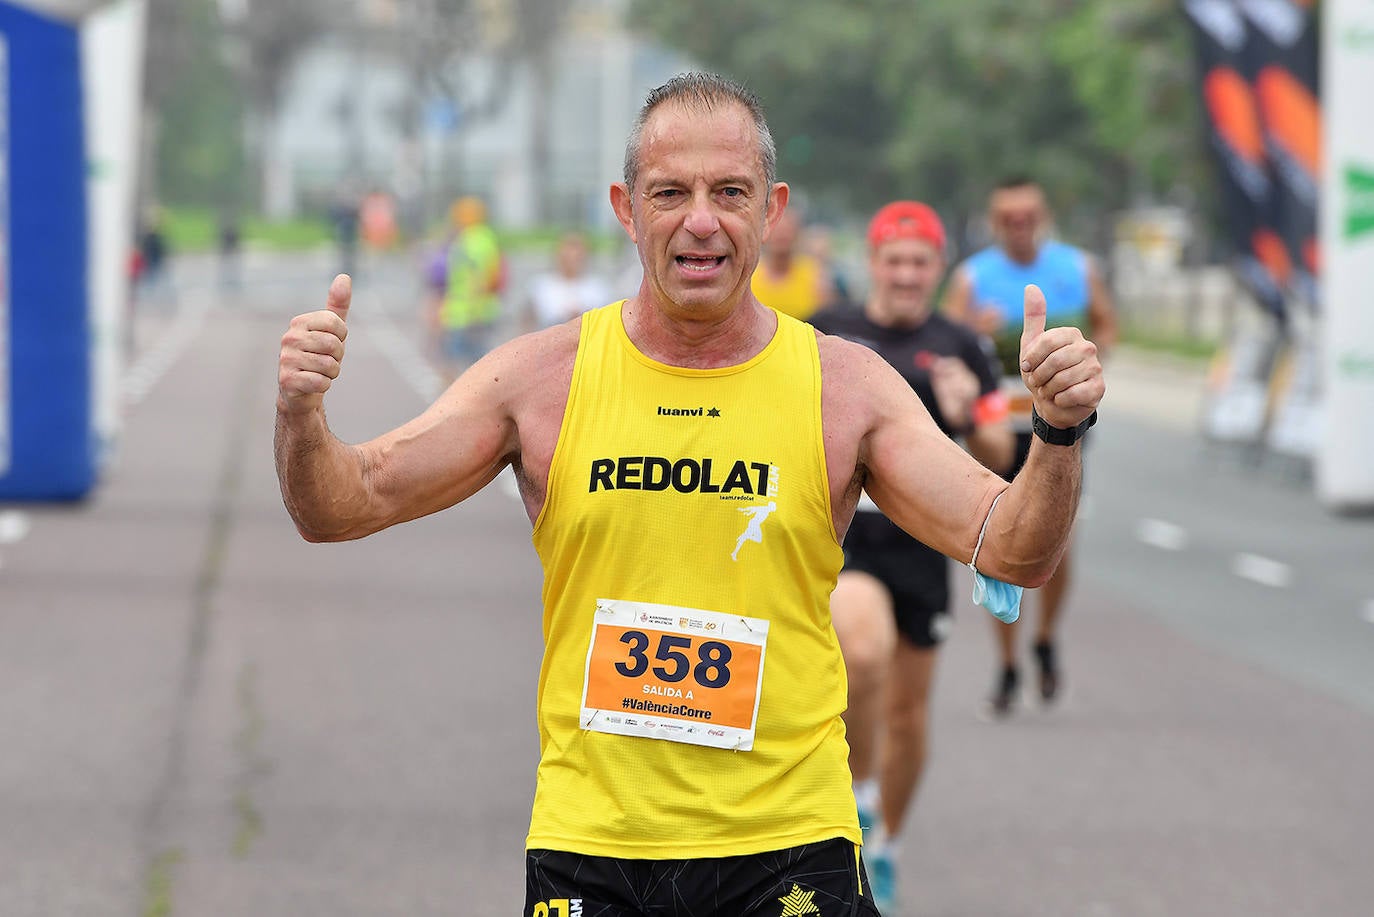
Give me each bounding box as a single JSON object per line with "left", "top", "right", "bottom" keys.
{"left": 813, "top": 201, "right": 1015, "bottom": 910}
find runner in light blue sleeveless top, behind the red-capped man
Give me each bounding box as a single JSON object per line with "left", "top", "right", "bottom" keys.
{"left": 941, "top": 176, "right": 1117, "bottom": 716}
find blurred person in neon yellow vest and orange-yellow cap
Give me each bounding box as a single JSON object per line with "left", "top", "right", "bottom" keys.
{"left": 436, "top": 197, "right": 504, "bottom": 377}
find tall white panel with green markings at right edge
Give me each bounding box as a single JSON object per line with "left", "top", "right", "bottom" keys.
{"left": 1316, "top": 0, "right": 1374, "bottom": 510}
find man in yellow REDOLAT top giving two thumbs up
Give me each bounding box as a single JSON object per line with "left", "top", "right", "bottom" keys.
{"left": 275, "top": 73, "right": 1105, "bottom": 917}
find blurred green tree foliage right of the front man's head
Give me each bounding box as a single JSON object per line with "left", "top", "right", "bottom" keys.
{"left": 632, "top": 0, "right": 1201, "bottom": 233}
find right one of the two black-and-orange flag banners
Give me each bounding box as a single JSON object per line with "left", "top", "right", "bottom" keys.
{"left": 1239, "top": 0, "right": 1322, "bottom": 307}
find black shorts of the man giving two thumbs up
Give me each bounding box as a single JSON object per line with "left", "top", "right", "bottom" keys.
{"left": 521, "top": 839, "right": 878, "bottom": 917}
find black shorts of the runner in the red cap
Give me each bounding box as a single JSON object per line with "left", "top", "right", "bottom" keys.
{"left": 845, "top": 511, "right": 951, "bottom": 649}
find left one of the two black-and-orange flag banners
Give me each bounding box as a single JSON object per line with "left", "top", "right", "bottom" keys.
{"left": 1183, "top": 0, "right": 1293, "bottom": 319}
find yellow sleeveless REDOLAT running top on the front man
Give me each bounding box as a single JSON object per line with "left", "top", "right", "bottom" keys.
{"left": 528, "top": 302, "right": 860, "bottom": 859}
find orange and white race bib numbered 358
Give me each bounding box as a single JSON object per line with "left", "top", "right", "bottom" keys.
{"left": 581, "top": 598, "right": 768, "bottom": 752}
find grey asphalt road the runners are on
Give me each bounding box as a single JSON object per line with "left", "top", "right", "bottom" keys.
{"left": 0, "top": 252, "right": 1374, "bottom": 917}
